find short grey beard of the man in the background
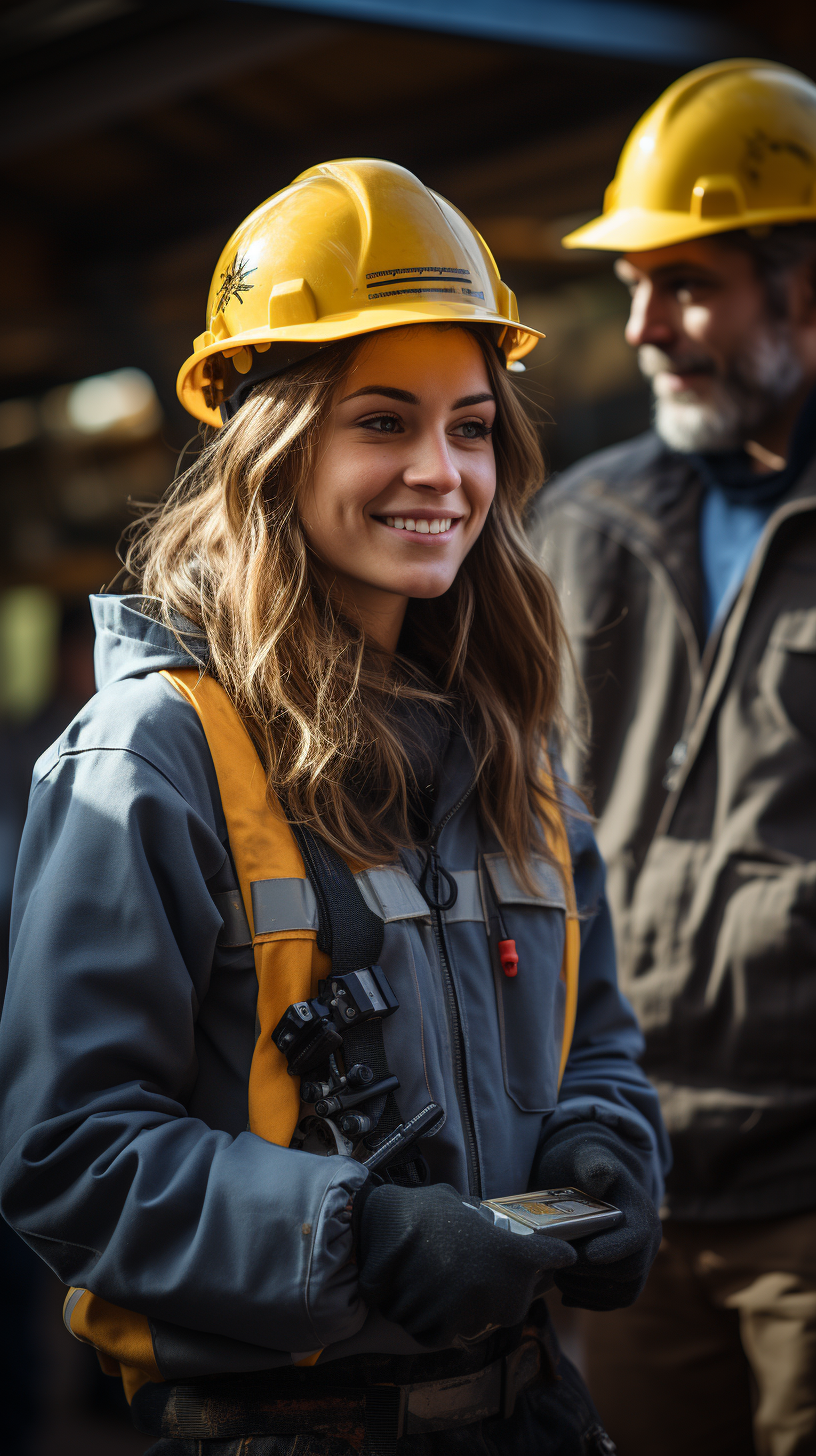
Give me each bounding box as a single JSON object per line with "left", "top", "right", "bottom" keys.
{"left": 638, "top": 329, "right": 804, "bottom": 451}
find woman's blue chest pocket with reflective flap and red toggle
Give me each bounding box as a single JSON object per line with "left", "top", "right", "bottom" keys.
{"left": 482, "top": 855, "right": 567, "bottom": 1112}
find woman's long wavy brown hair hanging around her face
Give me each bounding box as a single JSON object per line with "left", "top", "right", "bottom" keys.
{"left": 125, "top": 325, "right": 565, "bottom": 885}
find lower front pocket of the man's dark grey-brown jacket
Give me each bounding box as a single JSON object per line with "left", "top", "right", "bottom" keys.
{"left": 621, "top": 839, "right": 816, "bottom": 1095}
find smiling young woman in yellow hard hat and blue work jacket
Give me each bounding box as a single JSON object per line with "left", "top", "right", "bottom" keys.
{"left": 0, "top": 162, "right": 664, "bottom": 1456}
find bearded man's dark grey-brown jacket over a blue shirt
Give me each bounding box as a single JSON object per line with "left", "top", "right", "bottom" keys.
{"left": 532, "top": 434, "right": 816, "bottom": 1219}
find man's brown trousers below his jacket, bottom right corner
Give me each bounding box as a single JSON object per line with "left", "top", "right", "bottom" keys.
{"left": 581, "top": 1213, "right": 816, "bottom": 1456}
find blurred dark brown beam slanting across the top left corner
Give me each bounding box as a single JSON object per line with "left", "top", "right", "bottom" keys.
{"left": 0, "top": 4, "right": 345, "bottom": 160}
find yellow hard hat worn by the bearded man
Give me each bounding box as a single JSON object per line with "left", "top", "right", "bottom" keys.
{"left": 562, "top": 60, "right": 816, "bottom": 252}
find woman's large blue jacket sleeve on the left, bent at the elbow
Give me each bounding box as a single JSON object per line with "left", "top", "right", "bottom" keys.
{"left": 0, "top": 733, "right": 366, "bottom": 1351}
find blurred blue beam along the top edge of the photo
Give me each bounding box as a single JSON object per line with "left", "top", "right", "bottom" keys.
{"left": 230, "top": 0, "right": 748, "bottom": 66}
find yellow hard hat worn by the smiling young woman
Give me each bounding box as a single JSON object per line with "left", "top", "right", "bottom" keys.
{"left": 176, "top": 157, "right": 544, "bottom": 425}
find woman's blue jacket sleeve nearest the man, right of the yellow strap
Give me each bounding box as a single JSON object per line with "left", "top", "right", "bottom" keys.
{"left": 539, "top": 792, "right": 672, "bottom": 1204}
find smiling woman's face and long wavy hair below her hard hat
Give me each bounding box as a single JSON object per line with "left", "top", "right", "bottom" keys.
{"left": 134, "top": 323, "right": 564, "bottom": 882}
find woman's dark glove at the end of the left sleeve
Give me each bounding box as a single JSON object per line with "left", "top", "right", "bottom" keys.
{"left": 354, "top": 1184, "right": 576, "bottom": 1348}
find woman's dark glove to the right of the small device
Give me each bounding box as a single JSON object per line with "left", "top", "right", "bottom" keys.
{"left": 536, "top": 1128, "right": 662, "bottom": 1309}
